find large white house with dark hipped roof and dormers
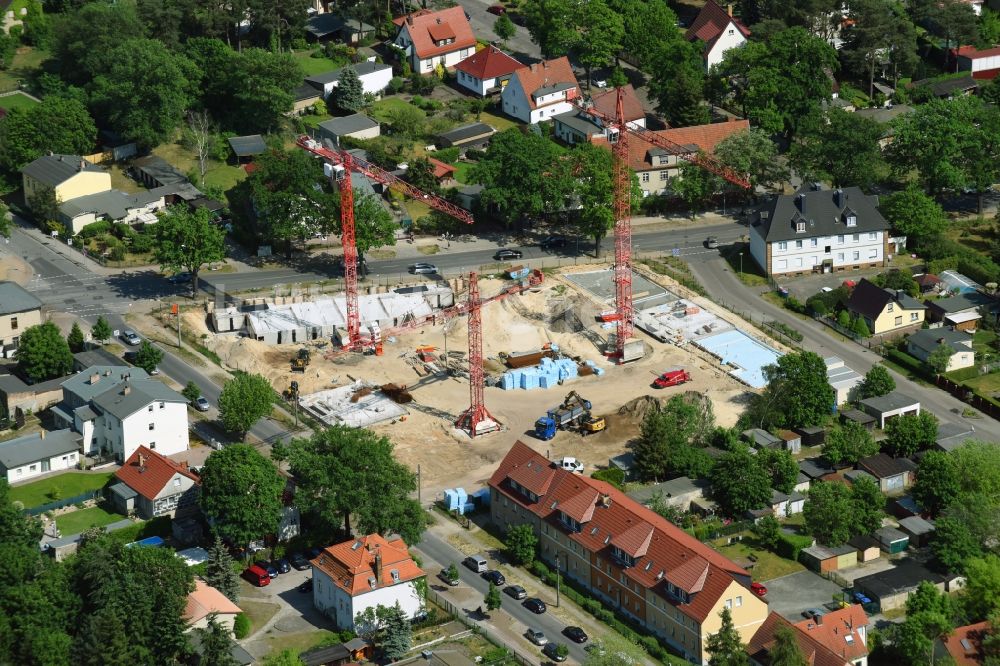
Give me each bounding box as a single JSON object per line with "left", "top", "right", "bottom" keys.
{"left": 748, "top": 187, "right": 892, "bottom": 278}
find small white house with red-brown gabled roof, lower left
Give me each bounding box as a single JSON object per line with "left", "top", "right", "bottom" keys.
{"left": 110, "top": 446, "right": 201, "bottom": 520}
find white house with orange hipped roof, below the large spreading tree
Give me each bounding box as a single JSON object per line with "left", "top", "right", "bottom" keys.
{"left": 312, "top": 534, "right": 425, "bottom": 629}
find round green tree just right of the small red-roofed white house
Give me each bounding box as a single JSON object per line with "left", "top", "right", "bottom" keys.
{"left": 198, "top": 444, "right": 285, "bottom": 546}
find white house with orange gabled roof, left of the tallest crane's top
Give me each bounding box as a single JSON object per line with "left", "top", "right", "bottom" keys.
{"left": 500, "top": 56, "right": 580, "bottom": 125}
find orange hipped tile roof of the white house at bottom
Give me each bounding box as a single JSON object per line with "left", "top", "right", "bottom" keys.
{"left": 312, "top": 534, "right": 424, "bottom": 596}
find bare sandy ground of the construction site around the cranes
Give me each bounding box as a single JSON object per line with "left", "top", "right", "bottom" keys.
{"left": 184, "top": 268, "right": 747, "bottom": 492}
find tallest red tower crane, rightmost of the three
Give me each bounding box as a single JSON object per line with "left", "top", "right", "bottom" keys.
{"left": 574, "top": 88, "right": 750, "bottom": 363}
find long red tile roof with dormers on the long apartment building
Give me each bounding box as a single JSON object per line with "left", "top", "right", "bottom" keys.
{"left": 489, "top": 441, "right": 750, "bottom": 623}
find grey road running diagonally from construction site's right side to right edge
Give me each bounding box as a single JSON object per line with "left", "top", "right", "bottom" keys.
{"left": 689, "top": 253, "right": 1000, "bottom": 441}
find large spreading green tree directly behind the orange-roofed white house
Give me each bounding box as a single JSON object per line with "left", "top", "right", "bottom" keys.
{"left": 288, "top": 426, "right": 427, "bottom": 544}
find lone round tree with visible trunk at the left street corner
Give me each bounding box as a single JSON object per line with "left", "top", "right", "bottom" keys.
{"left": 153, "top": 206, "right": 226, "bottom": 294}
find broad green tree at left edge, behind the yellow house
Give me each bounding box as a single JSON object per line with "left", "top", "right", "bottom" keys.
{"left": 0, "top": 96, "right": 97, "bottom": 171}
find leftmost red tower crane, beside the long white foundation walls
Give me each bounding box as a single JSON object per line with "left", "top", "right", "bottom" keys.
{"left": 296, "top": 135, "right": 481, "bottom": 350}
